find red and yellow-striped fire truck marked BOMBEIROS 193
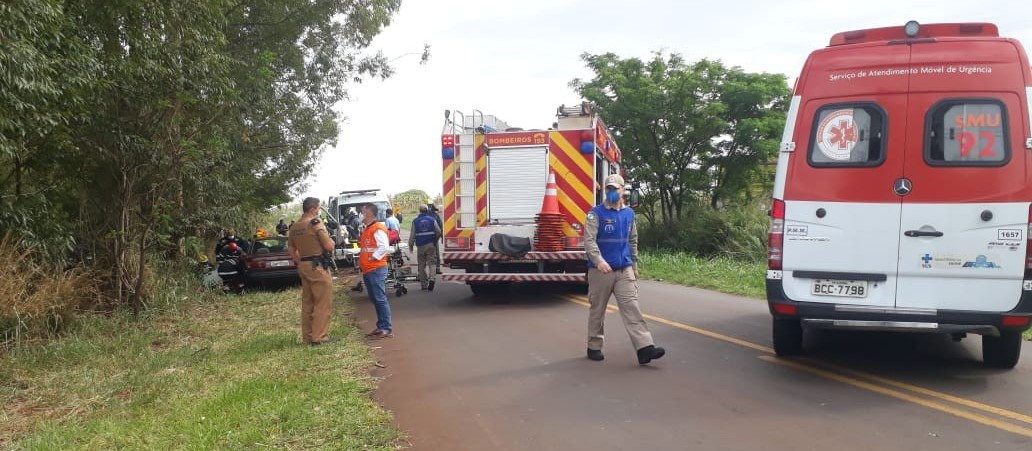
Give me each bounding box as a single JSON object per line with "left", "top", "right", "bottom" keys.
{"left": 441, "top": 102, "right": 637, "bottom": 294}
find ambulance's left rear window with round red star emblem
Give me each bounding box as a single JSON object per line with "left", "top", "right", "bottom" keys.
{"left": 808, "top": 103, "right": 885, "bottom": 167}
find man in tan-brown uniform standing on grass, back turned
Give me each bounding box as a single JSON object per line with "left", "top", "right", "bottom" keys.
{"left": 287, "top": 197, "right": 336, "bottom": 345}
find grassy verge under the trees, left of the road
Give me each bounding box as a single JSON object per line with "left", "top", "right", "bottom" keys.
{"left": 0, "top": 280, "right": 399, "bottom": 450}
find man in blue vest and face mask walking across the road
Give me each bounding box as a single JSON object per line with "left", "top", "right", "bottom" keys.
{"left": 584, "top": 173, "right": 666, "bottom": 365}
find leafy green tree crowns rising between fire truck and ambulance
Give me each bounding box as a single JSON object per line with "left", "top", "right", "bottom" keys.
{"left": 571, "top": 52, "right": 788, "bottom": 221}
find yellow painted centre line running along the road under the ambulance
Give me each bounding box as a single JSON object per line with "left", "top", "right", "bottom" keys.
{"left": 563, "top": 296, "right": 1032, "bottom": 437}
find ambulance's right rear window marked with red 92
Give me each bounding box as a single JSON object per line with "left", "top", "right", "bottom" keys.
{"left": 925, "top": 99, "right": 1010, "bottom": 166}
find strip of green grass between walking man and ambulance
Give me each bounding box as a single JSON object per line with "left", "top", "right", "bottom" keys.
{"left": 640, "top": 252, "right": 767, "bottom": 298}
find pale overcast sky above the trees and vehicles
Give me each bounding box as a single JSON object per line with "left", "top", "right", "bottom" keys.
{"left": 295, "top": 0, "right": 1032, "bottom": 199}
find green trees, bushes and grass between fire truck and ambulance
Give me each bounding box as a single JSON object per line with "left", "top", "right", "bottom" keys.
{"left": 571, "top": 52, "right": 789, "bottom": 305}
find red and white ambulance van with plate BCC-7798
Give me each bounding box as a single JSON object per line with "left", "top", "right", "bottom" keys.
{"left": 767, "top": 22, "right": 1032, "bottom": 367}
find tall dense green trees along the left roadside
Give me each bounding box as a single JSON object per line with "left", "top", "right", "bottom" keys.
{"left": 0, "top": 0, "right": 410, "bottom": 307}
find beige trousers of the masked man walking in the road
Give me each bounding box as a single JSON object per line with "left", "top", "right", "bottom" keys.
{"left": 587, "top": 266, "right": 653, "bottom": 351}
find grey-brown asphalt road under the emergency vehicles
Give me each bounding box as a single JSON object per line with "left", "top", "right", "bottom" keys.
{"left": 356, "top": 262, "right": 1032, "bottom": 451}
